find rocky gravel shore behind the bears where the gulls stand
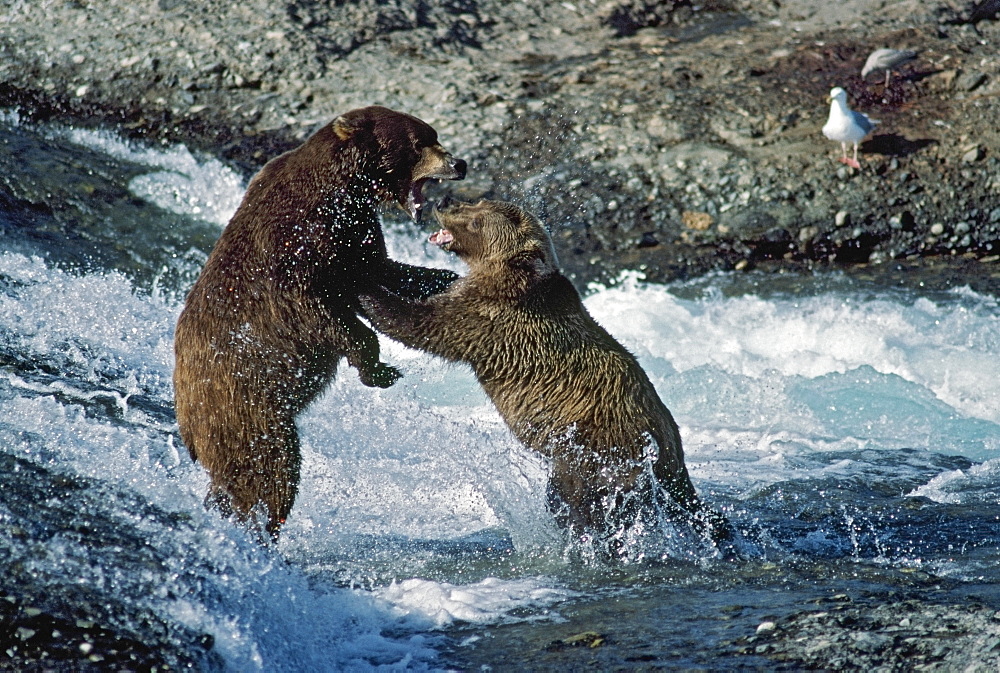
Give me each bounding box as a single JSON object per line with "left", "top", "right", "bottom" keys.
{"left": 0, "top": 0, "right": 1000, "bottom": 292}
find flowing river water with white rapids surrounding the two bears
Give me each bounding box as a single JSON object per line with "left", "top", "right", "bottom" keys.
{"left": 0, "top": 112, "right": 1000, "bottom": 671}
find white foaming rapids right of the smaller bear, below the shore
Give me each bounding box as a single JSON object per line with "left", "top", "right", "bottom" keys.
{"left": 586, "top": 278, "right": 1000, "bottom": 468}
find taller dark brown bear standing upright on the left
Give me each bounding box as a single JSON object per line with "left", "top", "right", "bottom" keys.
{"left": 174, "top": 107, "right": 466, "bottom": 539}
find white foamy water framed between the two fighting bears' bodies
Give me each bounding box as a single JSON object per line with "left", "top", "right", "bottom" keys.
{"left": 286, "top": 370, "right": 564, "bottom": 548}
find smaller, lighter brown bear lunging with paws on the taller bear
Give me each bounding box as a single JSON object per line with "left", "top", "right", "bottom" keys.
{"left": 362, "top": 201, "right": 728, "bottom": 540}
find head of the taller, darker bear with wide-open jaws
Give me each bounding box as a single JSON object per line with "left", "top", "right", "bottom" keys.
{"left": 330, "top": 105, "right": 467, "bottom": 220}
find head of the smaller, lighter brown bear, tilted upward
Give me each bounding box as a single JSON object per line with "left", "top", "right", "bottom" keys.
{"left": 430, "top": 199, "right": 557, "bottom": 274}
